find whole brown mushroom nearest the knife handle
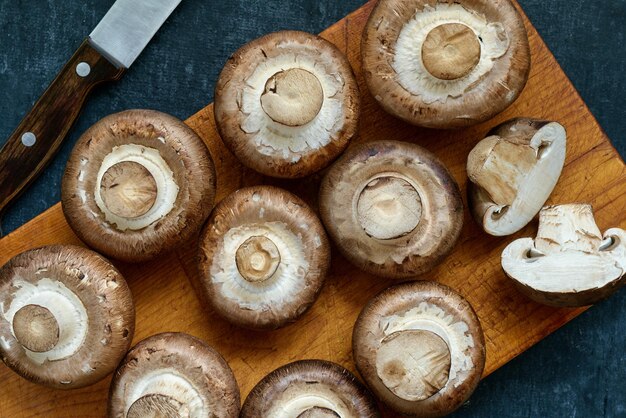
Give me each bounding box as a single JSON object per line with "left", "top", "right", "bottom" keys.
{"left": 62, "top": 110, "right": 215, "bottom": 262}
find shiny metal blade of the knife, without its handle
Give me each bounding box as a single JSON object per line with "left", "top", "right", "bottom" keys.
{"left": 89, "top": 0, "right": 181, "bottom": 68}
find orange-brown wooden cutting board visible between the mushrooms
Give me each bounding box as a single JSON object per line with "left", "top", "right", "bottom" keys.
{"left": 0, "top": 2, "right": 626, "bottom": 418}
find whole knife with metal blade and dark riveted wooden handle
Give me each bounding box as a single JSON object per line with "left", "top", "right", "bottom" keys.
{"left": 0, "top": 0, "right": 181, "bottom": 232}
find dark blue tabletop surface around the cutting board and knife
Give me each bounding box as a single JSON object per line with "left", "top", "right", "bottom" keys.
{"left": 0, "top": 0, "right": 626, "bottom": 417}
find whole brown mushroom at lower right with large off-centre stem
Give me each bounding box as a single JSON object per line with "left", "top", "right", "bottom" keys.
{"left": 352, "top": 281, "right": 485, "bottom": 417}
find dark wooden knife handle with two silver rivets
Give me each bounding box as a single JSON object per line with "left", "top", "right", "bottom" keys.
{"left": 0, "top": 40, "right": 125, "bottom": 212}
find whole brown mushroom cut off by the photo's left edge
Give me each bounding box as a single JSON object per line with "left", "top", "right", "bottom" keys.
{"left": 0, "top": 245, "right": 135, "bottom": 389}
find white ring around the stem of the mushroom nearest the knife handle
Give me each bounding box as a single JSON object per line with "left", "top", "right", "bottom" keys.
{"left": 93, "top": 144, "right": 179, "bottom": 231}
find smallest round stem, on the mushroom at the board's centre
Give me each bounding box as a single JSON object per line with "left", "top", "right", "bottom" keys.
{"left": 235, "top": 236, "right": 280, "bottom": 283}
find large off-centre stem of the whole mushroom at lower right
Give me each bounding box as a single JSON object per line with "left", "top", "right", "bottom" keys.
{"left": 376, "top": 330, "right": 452, "bottom": 401}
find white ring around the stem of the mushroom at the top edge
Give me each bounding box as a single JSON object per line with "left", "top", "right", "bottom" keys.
{"left": 392, "top": 2, "right": 514, "bottom": 103}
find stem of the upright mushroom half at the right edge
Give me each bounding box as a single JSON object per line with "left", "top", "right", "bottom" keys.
{"left": 535, "top": 204, "right": 602, "bottom": 255}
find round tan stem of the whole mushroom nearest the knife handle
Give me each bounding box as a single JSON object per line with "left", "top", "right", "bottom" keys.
{"left": 100, "top": 161, "right": 158, "bottom": 218}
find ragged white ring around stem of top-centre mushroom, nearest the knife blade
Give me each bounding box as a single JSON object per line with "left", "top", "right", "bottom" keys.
{"left": 237, "top": 50, "right": 345, "bottom": 163}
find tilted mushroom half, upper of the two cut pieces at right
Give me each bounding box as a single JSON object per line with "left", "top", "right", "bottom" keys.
{"left": 467, "top": 118, "right": 567, "bottom": 236}
